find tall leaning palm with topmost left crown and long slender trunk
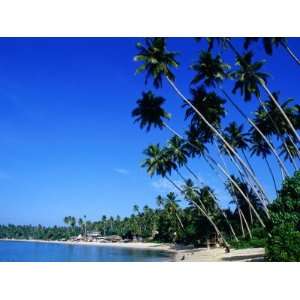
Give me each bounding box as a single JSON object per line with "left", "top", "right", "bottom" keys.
{"left": 134, "top": 38, "right": 268, "bottom": 204}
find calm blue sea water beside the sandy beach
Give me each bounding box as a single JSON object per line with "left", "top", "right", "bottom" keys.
{"left": 0, "top": 241, "right": 172, "bottom": 262}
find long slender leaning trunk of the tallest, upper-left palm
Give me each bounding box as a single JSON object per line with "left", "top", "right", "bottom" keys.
{"left": 166, "top": 76, "right": 267, "bottom": 204}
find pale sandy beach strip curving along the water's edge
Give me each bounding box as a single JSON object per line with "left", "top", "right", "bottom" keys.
{"left": 0, "top": 239, "right": 265, "bottom": 262}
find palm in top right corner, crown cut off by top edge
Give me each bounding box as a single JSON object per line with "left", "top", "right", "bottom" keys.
{"left": 244, "top": 37, "right": 300, "bottom": 65}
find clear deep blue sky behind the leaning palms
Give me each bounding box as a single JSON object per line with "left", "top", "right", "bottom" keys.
{"left": 0, "top": 38, "right": 300, "bottom": 225}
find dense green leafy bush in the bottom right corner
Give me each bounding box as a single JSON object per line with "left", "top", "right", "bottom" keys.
{"left": 266, "top": 171, "right": 300, "bottom": 261}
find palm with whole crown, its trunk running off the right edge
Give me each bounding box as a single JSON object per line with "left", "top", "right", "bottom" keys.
{"left": 232, "top": 52, "right": 300, "bottom": 142}
